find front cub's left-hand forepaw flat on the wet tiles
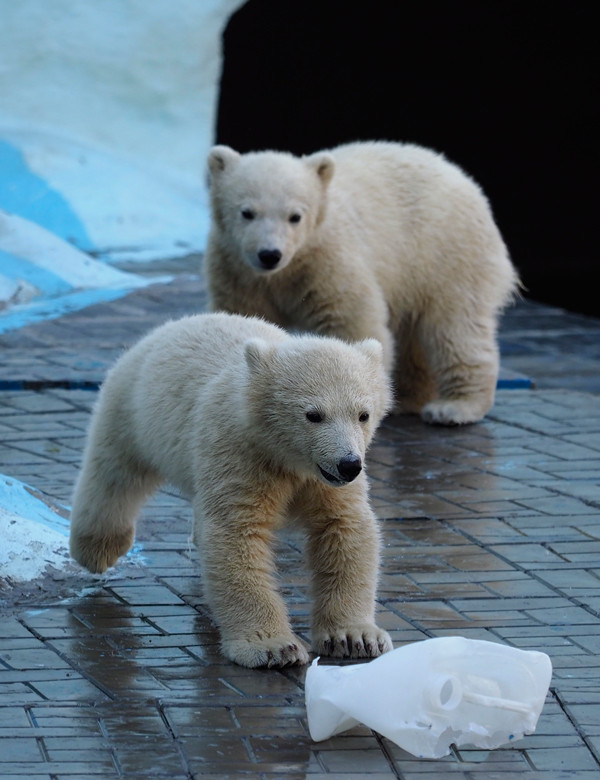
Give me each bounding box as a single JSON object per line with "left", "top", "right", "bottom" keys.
{"left": 221, "top": 631, "right": 308, "bottom": 669}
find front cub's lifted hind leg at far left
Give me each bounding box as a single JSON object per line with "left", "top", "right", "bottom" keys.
{"left": 70, "top": 402, "right": 161, "bottom": 573}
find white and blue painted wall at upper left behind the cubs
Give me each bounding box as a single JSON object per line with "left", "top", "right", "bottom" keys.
{"left": 0, "top": 0, "right": 243, "bottom": 259}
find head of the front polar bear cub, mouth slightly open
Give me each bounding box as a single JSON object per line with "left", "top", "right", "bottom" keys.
{"left": 245, "top": 336, "right": 391, "bottom": 486}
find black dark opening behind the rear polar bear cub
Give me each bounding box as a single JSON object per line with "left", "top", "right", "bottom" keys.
{"left": 217, "top": 0, "right": 600, "bottom": 316}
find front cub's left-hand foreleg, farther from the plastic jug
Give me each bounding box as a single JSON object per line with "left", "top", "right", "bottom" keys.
{"left": 194, "top": 496, "right": 308, "bottom": 668}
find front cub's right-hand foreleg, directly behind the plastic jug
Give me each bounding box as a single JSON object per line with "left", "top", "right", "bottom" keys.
{"left": 302, "top": 482, "right": 392, "bottom": 658}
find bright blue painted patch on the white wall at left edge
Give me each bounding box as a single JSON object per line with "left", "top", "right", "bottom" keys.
{"left": 0, "top": 140, "right": 95, "bottom": 251}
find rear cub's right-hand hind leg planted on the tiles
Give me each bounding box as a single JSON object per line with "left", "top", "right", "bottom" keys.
{"left": 414, "top": 310, "right": 500, "bottom": 425}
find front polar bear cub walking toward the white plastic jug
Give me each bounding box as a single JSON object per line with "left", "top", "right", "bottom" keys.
{"left": 70, "top": 314, "right": 392, "bottom": 667}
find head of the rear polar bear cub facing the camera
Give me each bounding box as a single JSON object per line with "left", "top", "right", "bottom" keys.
{"left": 208, "top": 146, "right": 334, "bottom": 273}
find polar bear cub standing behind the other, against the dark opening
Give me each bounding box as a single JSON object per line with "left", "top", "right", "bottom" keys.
{"left": 205, "top": 137, "right": 518, "bottom": 425}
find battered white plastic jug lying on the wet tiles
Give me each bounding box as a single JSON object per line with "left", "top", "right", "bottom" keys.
{"left": 306, "top": 636, "right": 552, "bottom": 758}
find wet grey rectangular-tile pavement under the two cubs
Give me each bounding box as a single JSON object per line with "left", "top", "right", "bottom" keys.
{"left": 0, "top": 264, "right": 600, "bottom": 780}
